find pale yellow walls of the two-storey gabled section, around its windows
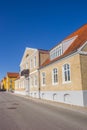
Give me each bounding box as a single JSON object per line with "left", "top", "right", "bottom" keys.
{"left": 19, "top": 49, "right": 49, "bottom": 91}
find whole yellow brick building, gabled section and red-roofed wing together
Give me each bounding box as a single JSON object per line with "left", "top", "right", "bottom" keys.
{"left": 15, "top": 24, "right": 87, "bottom": 106}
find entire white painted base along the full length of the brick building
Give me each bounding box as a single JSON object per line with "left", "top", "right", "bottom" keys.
{"left": 15, "top": 90, "right": 87, "bottom": 106}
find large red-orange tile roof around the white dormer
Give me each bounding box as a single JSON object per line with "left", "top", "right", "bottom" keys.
{"left": 41, "top": 24, "right": 87, "bottom": 67}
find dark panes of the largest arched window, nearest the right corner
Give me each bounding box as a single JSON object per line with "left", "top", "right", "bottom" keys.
{"left": 63, "top": 64, "right": 70, "bottom": 82}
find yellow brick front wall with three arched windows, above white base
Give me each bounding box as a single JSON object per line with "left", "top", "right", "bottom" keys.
{"left": 40, "top": 54, "right": 82, "bottom": 91}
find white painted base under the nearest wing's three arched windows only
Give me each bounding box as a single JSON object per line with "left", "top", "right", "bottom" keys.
{"left": 40, "top": 91, "right": 84, "bottom": 106}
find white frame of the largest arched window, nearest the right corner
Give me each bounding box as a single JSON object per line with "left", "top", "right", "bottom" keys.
{"left": 62, "top": 63, "right": 71, "bottom": 84}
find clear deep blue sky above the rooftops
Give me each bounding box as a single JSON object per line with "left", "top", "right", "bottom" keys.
{"left": 0, "top": 0, "right": 87, "bottom": 80}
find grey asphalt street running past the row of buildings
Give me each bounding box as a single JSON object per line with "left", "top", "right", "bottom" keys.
{"left": 0, "top": 92, "right": 87, "bottom": 130}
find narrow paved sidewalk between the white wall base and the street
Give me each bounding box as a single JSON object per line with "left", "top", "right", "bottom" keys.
{"left": 12, "top": 93, "right": 87, "bottom": 115}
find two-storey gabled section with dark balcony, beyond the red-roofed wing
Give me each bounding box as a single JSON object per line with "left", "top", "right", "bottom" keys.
{"left": 15, "top": 48, "right": 49, "bottom": 95}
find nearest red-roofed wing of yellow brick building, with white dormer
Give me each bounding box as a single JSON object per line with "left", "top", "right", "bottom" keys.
{"left": 39, "top": 24, "right": 87, "bottom": 106}
